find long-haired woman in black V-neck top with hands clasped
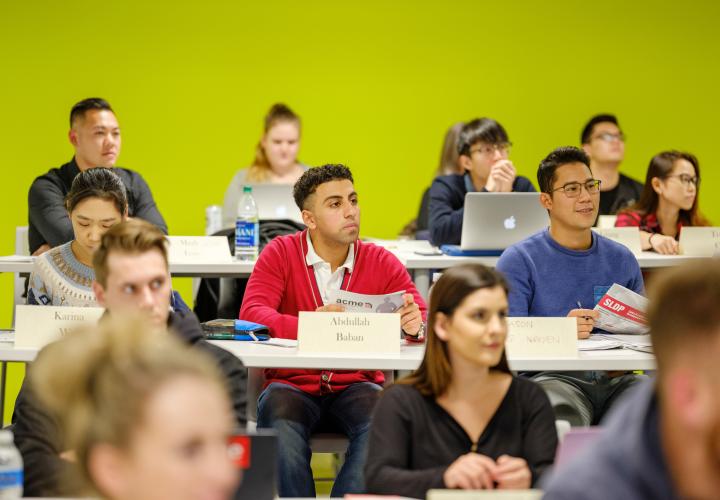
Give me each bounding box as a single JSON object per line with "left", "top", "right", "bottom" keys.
{"left": 365, "top": 264, "right": 557, "bottom": 498}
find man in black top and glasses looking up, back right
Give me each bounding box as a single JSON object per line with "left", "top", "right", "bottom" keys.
{"left": 580, "top": 114, "right": 643, "bottom": 215}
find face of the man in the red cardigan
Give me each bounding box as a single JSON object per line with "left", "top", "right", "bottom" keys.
{"left": 302, "top": 179, "right": 360, "bottom": 245}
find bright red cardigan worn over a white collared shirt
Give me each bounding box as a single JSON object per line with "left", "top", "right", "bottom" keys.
{"left": 240, "top": 231, "right": 427, "bottom": 396}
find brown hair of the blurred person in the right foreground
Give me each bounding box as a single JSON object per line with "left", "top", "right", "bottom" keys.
{"left": 647, "top": 259, "right": 720, "bottom": 373}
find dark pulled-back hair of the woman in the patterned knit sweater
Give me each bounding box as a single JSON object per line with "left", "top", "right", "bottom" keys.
{"left": 65, "top": 167, "right": 128, "bottom": 215}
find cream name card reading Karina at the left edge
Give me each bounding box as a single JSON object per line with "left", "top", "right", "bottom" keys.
{"left": 15, "top": 305, "right": 105, "bottom": 349}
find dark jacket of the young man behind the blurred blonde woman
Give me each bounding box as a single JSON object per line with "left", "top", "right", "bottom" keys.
{"left": 12, "top": 312, "right": 247, "bottom": 497}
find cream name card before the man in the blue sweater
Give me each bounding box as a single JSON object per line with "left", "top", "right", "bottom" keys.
{"left": 505, "top": 317, "right": 578, "bottom": 359}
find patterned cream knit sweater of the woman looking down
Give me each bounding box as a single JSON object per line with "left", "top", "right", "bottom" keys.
{"left": 27, "top": 242, "right": 97, "bottom": 307}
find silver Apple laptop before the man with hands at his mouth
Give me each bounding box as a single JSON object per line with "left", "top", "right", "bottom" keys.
{"left": 460, "top": 193, "right": 550, "bottom": 250}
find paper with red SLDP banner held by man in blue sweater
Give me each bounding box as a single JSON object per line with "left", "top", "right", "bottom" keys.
{"left": 595, "top": 283, "right": 648, "bottom": 334}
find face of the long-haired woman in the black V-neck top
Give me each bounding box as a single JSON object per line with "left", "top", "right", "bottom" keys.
{"left": 435, "top": 286, "right": 508, "bottom": 367}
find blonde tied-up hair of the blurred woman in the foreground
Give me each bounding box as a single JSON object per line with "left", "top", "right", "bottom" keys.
{"left": 29, "top": 317, "right": 226, "bottom": 493}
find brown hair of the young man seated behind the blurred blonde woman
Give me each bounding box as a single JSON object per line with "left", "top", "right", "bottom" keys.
{"left": 93, "top": 219, "right": 168, "bottom": 286}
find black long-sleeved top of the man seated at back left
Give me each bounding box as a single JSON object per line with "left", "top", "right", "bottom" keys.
{"left": 28, "top": 158, "right": 167, "bottom": 253}
